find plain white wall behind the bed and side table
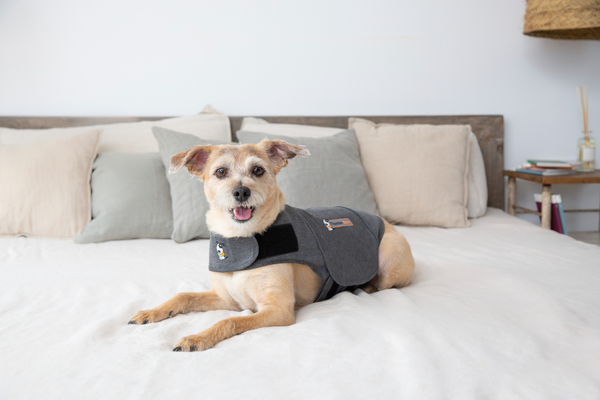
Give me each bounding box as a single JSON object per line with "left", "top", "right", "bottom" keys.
{"left": 0, "top": 0, "right": 600, "bottom": 230}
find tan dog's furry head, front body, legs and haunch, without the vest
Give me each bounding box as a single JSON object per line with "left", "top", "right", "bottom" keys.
{"left": 129, "top": 140, "right": 414, "bottom": 351}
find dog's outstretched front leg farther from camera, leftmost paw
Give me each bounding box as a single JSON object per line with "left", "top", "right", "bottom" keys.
{"left": 129, "top": 290, "right": 240, "bottom": 325}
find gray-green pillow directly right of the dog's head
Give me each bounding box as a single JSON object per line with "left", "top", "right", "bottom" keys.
{"left": 237, "top": 129, "right": 378, "bottom": 214}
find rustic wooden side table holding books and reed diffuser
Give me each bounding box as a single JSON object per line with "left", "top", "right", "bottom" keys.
{"left": 503, "top": 169, "right": 600, "bottom": 230}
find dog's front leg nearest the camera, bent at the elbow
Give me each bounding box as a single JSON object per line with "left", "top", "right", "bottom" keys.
{"left": 173, "top": 264, "right": 296, "bottom": 351}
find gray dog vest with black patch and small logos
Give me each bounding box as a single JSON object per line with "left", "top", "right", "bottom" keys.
{"left": 208, "top": 205, "right": 385, "bottom": 301}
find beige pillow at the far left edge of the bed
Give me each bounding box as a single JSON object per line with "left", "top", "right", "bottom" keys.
{"left": 0, "top": 129, "right": 102, "bottom": 238}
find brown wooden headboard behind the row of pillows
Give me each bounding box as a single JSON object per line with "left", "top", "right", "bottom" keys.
{"left": 0, "top": 115, "right": 505, "bottom": 210}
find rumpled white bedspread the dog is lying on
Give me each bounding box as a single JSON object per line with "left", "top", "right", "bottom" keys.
{"left": 0, "top": 209, "right": 600, "bottom": 399}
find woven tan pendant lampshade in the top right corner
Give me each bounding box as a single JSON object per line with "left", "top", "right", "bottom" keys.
{"left": 523, "top": 0, "right": 600, "bottom": 40}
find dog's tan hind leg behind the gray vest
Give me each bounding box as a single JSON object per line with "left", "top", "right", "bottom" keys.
{"left": 364, "top": 222, "right": 415, "bottom": 293}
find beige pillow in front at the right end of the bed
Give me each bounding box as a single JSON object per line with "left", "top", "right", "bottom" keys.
{"left": 349, "top": 118, "right": 471, "bottom": 228}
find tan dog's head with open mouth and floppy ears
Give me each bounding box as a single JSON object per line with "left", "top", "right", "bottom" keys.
{"left": 169, "top": 140, "right": 310, "bottom": 237}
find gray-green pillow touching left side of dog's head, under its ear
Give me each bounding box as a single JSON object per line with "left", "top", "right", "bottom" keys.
{"left": 152, "top": 127, "right": 230, "bottom": 243}
